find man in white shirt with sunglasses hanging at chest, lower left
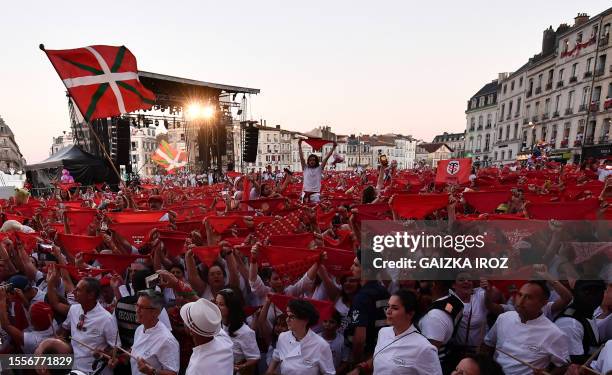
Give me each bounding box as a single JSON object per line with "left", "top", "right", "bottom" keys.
{"left": 47, "top": 274, "right": 121, "bottom": 375}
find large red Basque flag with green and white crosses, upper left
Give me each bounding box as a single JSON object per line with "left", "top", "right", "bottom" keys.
{"left": 45, "top": 45, "right": 155, "bottom": 121}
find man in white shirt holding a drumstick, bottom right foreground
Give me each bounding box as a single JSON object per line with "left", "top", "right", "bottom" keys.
{"left": 485, "top": 281, "right": 569, "bottom": 375}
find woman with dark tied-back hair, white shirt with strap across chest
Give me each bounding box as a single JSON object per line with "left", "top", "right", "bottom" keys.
{"left": 349, "top": 289, "right": 442, "bottom": 375}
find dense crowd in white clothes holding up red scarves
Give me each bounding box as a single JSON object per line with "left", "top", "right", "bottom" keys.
{"left": 0, "top": 145, "right": 612, "bottom": 375}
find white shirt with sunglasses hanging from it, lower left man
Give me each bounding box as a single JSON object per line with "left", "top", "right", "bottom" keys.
{"left": 62, "top": 303, "right": 121, "bottom": 375}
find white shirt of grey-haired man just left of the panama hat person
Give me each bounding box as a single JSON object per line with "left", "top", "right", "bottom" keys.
{"left": 130, "top": 321, "right": 180, "bottom": 375}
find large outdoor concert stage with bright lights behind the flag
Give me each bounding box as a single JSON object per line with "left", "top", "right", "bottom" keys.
{"left": 68, "top": 71, "right": 260, "bottom": 173}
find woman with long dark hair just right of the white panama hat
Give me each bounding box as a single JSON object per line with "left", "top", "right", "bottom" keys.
{"left": 216, "top": 288, "right": 261, "bottom": 374}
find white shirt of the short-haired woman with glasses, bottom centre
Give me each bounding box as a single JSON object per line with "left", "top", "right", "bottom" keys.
{"left": 272, "top": 329, "right": 336, "bottom": 375}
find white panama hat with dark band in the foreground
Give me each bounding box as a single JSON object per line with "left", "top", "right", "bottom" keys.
{"left": 181, "top": 298, "right": 221, "bottom": 337}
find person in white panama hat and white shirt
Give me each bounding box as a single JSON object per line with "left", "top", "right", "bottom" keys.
{"left": 181, "top": 298, "right": 234, "bottom": 375}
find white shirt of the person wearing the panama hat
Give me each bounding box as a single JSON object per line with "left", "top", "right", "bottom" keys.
{"left": 185, "top": 330, "right": 234, "bottom": 375}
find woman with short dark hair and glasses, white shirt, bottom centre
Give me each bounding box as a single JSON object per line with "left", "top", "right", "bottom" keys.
{"left": 266, "top": 299, "right": 336, "bottom": 375}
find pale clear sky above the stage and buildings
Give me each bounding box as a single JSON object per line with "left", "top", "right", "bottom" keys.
{"left": 0, "top": 0, "right": 610, "bottom": 163}
